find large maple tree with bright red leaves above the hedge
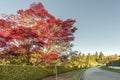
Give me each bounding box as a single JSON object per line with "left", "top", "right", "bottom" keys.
{"left": 0, "top": 3, "right": 77, "bottom": 64}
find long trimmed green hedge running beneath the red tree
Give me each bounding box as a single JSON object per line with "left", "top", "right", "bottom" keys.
{"left": 0, "top": 65, "right": 82, "bottom": 80}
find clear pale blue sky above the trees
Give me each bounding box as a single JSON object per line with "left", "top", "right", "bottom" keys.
{"left": 0, "top": 0, "right": 120, "bottom": 55}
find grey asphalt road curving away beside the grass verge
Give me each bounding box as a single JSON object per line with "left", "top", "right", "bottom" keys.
{"left": 81, "top": 67, "right": 120, "bottom": 80}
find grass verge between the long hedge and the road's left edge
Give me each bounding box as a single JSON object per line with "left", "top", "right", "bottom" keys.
{"left": 43, "top": 69, "right": 86, "bottom": 80}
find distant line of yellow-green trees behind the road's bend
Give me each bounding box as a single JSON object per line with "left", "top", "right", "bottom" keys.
{"left": 62, "top": 52, "right": 120, "bottom": 67}
